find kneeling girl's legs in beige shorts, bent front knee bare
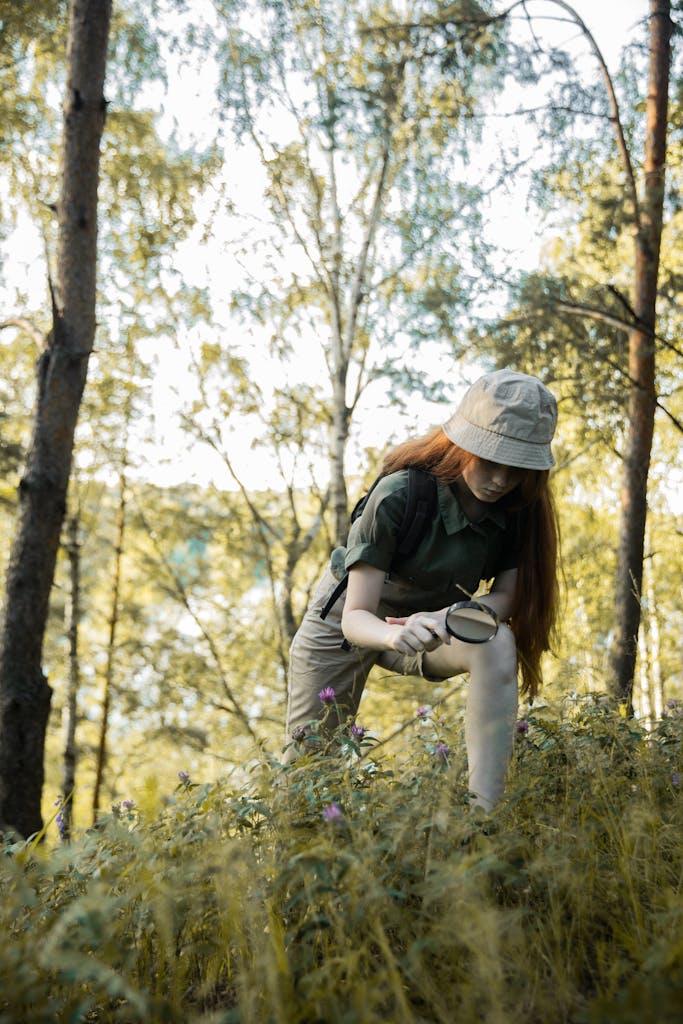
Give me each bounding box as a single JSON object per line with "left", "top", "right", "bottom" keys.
{"left": 285, "top": 571, "right": 517, "bottom": 810}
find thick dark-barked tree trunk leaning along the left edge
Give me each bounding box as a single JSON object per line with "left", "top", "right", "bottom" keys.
{"left": 0, "top": 0, "right": 112, "bottom": 836}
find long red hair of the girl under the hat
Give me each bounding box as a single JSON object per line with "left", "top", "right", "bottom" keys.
{"left": 382, "top": 427, "right": 559, "bottom": 699}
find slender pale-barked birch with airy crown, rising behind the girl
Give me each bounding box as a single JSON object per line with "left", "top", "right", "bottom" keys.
{"left": 216, "top": 0, "right": 495, "bottom": 544}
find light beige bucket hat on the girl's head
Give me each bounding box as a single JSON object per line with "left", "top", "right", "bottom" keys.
{"left": 442, "top": 370, "right": 557, "bottom": 469}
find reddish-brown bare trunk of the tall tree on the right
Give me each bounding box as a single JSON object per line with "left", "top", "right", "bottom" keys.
{"left": 610, "top": 0, "right": 672, "bottom": 710}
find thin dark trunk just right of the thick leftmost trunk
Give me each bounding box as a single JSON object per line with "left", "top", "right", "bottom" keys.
{"left": 59, "top": 515, "right": 81, "bottom": 843}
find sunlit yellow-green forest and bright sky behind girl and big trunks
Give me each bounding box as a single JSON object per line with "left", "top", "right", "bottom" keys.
{"left": 0, "top": 0, "right": 683, "bottom": 843}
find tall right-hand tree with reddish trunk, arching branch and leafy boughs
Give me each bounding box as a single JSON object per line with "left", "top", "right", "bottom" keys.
{"left": 419, "top": 0, "right": 683, "bottom": 708}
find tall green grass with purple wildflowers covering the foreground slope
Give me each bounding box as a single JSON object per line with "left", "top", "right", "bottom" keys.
{"left": 0, "top": 697, "right": 683, "bottom": 1024}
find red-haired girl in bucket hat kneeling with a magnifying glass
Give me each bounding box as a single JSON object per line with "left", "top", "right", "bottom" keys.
{"left": 285, "top": 370, "right": 558, "bottom": 810}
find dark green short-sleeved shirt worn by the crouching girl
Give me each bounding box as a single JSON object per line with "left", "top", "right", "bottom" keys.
{"left": 344, "top": 470, "right": 523, "bottom": 611}
